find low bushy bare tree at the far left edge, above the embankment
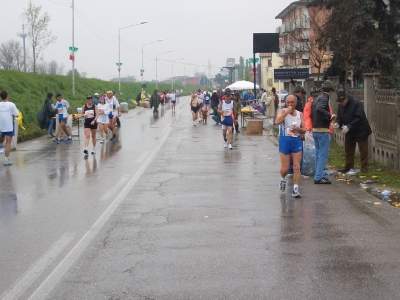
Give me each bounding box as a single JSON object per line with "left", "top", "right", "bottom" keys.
{"left": 0, "top": 40, "right": 24, "bottom": 71}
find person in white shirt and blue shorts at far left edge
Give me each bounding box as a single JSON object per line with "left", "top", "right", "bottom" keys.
{"left": 0, "top": 91, "right": 19, "bottom": 166}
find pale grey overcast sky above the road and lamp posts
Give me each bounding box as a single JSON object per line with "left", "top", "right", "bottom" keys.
{"left": 0, "top": 0, "right": 293, "bottom": 80}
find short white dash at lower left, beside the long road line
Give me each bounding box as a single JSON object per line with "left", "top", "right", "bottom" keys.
{"left": 1, "top": 233, "right": 74, "bottom": 300}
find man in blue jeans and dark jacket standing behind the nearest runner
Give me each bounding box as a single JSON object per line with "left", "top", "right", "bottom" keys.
{"left": 311, "top": 80, "right": 336, "bottom": 184}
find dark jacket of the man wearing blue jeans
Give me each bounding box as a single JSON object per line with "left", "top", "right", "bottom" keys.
{"left": 311, "top": 92, "right": 332, "bottom": 133}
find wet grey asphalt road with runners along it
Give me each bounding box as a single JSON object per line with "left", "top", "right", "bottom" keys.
{"left": 0, "top": 97, "right": 400, "bottom": 299}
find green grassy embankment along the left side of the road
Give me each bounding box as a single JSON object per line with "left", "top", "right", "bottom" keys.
{"left": 0, "top": 70, "right": 195, "bottom": 141}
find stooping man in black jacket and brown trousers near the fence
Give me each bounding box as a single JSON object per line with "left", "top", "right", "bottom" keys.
{"left": 333, "top": 91, "right": 372, "bottom": 173}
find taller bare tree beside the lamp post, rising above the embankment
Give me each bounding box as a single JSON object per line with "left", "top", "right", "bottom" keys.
{"left": 22, "top": 1, "right": 57, "bottom": 73}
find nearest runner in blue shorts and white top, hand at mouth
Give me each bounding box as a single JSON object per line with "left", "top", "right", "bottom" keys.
{"left": 275, "top": 95, "right": 306, "bottom": 198}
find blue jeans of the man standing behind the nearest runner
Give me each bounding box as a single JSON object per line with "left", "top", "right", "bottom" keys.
{"left": 313, "top": 132, "right": 331, "bottom": 180}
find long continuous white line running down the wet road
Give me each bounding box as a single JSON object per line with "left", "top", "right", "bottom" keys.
{"left": 29, "top": 106, "right": 181, "bottom": 300}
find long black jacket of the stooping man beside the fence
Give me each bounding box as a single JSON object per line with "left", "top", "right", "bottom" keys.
{"left": 336, "top": 95, "right": 372, "bottom": 143}
